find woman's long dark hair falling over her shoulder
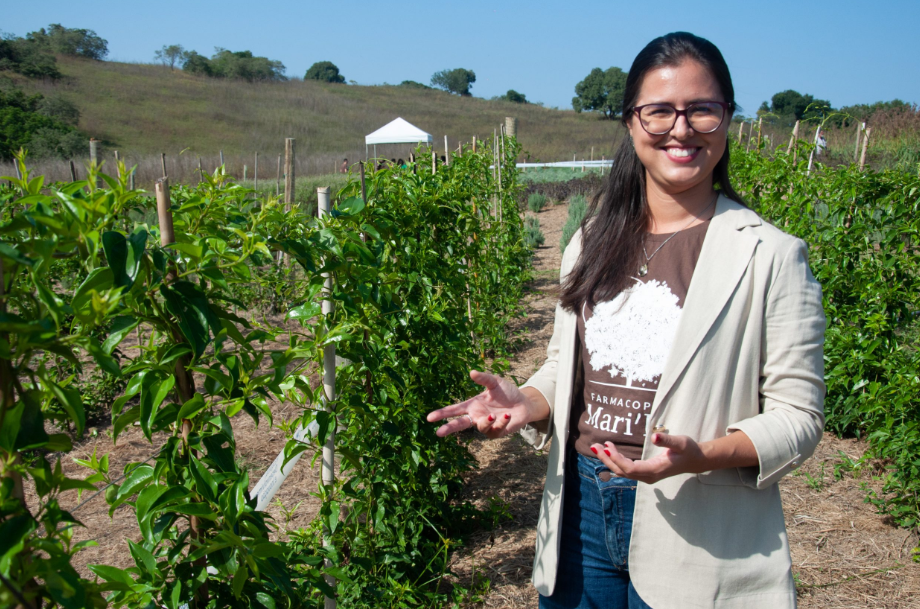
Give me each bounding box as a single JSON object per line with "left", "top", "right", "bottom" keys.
{"left": 561, "top": 32, "right": 744, "bottom": 311}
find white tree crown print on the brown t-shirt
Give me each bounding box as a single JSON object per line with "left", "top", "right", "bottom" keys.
{"left": 585, "top": 280, "right": 681, "bottom": 383}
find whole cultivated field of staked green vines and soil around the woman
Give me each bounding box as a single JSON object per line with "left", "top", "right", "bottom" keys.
{"left": 0, "top": 123, "right": 920, "bottom": 609}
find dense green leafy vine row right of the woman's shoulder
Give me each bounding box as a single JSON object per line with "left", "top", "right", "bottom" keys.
{"left": 732, "top": 143, "right": 920, "bottom": 528}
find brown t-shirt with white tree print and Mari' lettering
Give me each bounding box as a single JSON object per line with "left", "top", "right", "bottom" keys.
{"left": 569, "top": 220, "right": 709, "bottom": 459}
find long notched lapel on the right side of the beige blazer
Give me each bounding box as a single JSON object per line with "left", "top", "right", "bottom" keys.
{"left": 652, "top": 195, "right": 761, "bottom": 415}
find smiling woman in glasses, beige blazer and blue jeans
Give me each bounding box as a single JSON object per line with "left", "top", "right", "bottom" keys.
{"left": 428, "top": 33, "right": 824, "bottom": 609}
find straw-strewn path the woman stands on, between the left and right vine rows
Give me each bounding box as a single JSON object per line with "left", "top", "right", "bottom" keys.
{"left": 452, "top": 198, "right": 920, "bottom": 609}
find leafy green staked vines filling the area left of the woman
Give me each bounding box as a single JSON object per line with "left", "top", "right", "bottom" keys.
{"left": 0, "top": 135, "right": 530, "bottom": 609}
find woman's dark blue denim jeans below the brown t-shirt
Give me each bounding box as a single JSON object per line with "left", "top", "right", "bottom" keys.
{"left": 540, "top": 446, "right": 650, "bottom": 609}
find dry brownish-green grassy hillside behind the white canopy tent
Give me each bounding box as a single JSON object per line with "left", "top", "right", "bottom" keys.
{"left": 15, "top": 57, "right": 620, "bottom": 179}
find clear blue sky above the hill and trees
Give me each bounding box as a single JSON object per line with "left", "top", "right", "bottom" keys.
{"left": 9, "top": 0, "right": 920, "bottom": 114}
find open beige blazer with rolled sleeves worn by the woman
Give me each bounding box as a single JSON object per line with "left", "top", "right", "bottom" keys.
{"left": 521, "top": 197, "right": 825, "bottom": 609}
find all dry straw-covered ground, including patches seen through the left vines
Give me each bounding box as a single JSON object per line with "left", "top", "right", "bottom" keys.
{"left": 21, "top": 198, "right": 920, "bottom": 609}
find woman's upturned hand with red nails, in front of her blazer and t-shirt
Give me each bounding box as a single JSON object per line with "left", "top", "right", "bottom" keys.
{"left": 591, "top": 432, "right": 713, "bottom": 484}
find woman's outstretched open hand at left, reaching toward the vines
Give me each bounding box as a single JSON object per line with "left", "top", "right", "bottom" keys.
{"left": 428, "top": 370, "right": 549, "bottom": 439}
